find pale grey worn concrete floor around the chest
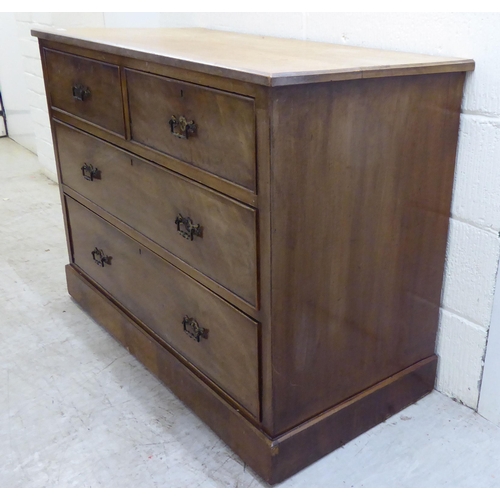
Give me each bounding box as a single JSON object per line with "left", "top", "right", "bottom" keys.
{"left": 0, "top": 139, "right": 500, "bottom": 487}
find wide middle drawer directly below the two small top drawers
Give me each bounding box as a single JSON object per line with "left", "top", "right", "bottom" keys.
{"left": 54, "top": 122, "right": 257, "bottom": 307}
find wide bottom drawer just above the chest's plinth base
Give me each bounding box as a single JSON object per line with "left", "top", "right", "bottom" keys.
{"left": 66, "top": 197, "right": 259, "bottom": 416}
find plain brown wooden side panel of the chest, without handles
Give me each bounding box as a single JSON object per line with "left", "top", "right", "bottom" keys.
{"left": 272, "top": 74, "right": 464, "bottom": 433}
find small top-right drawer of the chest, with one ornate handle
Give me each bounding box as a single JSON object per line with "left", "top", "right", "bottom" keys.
{"left": 125, "top": 70, "right": 255, "bottom": 191}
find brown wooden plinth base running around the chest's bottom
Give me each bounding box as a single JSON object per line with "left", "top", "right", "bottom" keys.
{"left": 66, "top": 265, "right": 437, "bottom": 484}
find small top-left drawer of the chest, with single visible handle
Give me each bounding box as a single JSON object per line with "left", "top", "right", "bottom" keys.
{"left": 44, "top": 49, "right": 125, "bottom": 137}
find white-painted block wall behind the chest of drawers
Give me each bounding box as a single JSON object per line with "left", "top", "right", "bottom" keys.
{"left": 6, "top": 13, "right": 500, "bottom": 409}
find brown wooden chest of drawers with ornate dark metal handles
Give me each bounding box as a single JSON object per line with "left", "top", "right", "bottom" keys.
{"left": 33, "top": 29, "right": 474, "bottom": 483}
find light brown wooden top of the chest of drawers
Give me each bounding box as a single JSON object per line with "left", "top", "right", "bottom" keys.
{"left": 31, "top": 28, "right": 474, "bottom": 86}
